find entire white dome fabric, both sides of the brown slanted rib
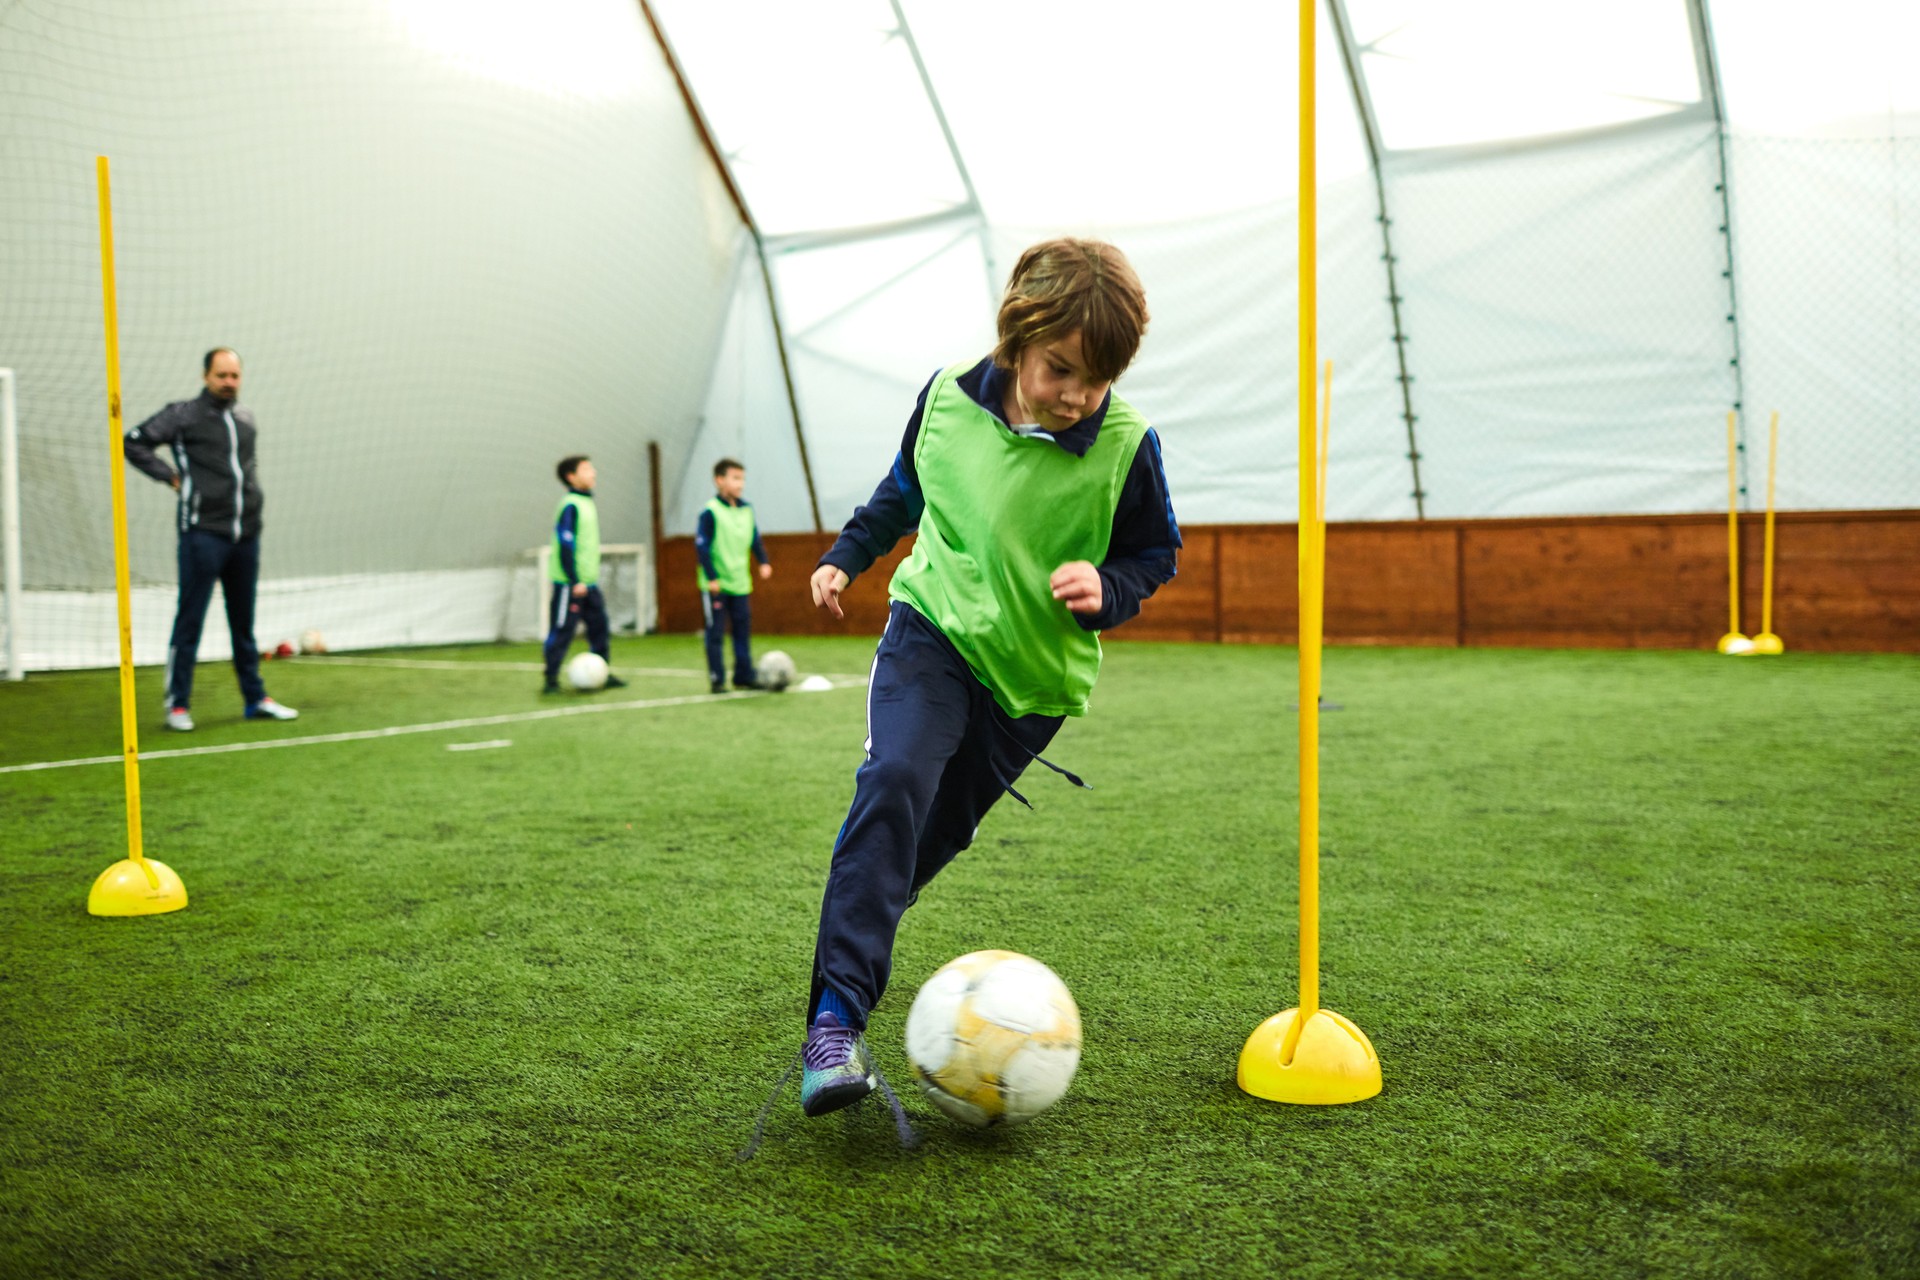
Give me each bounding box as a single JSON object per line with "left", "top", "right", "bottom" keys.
{"left": 0, "top": 0, "right": 1920, "bottom": 666}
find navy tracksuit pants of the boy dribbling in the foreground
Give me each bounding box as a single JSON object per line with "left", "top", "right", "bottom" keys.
{"left": 806, "top": 601, "right": 1062, "bottom": 1021}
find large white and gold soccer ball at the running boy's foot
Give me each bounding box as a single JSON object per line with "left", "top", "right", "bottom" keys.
{"left": 906, "top": 952, "right": 1081, "bottom": 1128}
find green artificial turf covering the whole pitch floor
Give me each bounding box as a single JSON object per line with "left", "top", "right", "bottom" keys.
{"left": 0, "top": 637, "right": 1920, "bottom": 1278}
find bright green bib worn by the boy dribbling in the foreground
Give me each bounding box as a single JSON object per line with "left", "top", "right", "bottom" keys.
{"left": 887, "top": 365, "right": 1146, "bottom": 716}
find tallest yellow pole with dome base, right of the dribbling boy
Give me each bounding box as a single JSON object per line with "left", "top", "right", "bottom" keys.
{"left": 1236, "top": 0, "right": 1380, "bottom": 1103}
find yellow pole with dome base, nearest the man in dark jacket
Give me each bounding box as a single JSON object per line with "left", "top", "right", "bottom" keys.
{"left": 86, "top": 155, "right": 186, "bottom": 915}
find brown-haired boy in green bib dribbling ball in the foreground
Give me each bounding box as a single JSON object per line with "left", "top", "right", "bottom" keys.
{"left": 801, "top": 240, "right": 1181, "bottom": 1115}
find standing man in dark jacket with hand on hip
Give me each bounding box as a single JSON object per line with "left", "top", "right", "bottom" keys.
{"left": 127, "top": 347, "right": 300, "bottom": 733}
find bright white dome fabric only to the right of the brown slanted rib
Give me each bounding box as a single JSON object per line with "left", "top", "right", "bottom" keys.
{"left": 653, "top": 0, "right": 1920, "bottom": 528}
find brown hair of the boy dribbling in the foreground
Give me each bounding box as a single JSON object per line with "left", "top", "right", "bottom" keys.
{"left": 993, "top": 238, "right": 1148, "bottom": 382}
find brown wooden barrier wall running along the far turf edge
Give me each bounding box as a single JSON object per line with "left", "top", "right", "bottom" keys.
{"left": 660, "top": 510, "right": 1920, "bottom": 652}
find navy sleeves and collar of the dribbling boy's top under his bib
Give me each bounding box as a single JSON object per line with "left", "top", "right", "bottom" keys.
{"left": 820, "top": 359, "right": 1181, "bottom": 631}
